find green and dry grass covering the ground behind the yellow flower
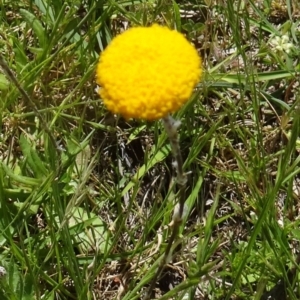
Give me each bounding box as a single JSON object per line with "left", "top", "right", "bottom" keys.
{"left": 0, "top": 0, "right": 300, "bottom": 300}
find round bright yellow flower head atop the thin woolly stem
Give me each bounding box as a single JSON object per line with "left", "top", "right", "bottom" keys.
{"left": 96, "top": 24, "right": 202, "bottom": 120}
